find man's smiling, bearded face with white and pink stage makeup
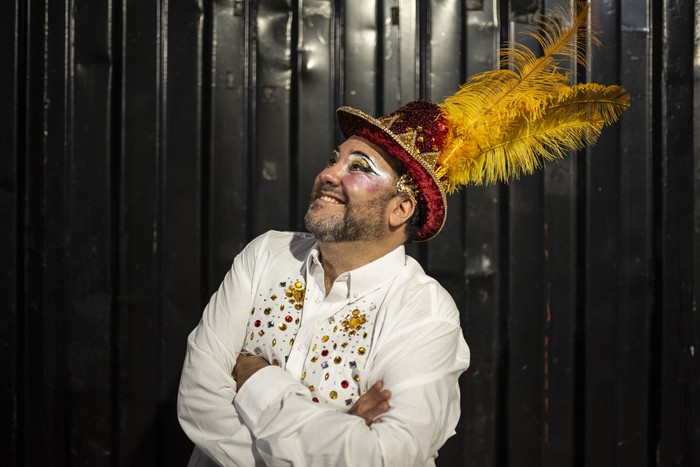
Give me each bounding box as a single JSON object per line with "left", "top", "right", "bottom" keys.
{"left": 304, "top": 136, "right": 397, "bottom": 242}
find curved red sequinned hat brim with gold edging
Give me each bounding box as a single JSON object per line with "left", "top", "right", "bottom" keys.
{"left": 336, "top": 106, "right": 447, "bottom": 241}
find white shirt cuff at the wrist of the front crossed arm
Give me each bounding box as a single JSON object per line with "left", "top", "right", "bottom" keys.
{"left": 233, "top": 365, "right": 296, "bottom": 430}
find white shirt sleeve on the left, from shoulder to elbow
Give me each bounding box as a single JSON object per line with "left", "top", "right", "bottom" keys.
{"left": 177, "top": 238, "right": 266, "bottom": 466}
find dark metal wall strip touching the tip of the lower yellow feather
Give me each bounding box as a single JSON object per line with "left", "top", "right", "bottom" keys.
{"left": 616, "top": 0, "right": 652, "bottom": 465}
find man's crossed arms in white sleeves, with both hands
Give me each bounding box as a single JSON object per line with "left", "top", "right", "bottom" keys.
{"left": 178, "top": 238, "right": 469, "bottom": 466}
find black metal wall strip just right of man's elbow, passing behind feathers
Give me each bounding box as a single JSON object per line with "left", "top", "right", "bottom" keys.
{"left": 459, "top": 1, "right": 508, "bottom": 467}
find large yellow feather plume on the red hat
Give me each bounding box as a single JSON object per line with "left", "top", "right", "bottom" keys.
{"left": 436, "top": 4, "right": 629, "bottom": 193}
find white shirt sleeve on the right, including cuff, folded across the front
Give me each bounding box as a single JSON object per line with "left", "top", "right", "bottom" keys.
{"left": 234, "top": 310, "right": 469, "bottom": 466}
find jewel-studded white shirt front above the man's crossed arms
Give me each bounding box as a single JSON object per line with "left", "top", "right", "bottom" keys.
{"left": 245, "top": 275, "right": 379, "bottom": 411}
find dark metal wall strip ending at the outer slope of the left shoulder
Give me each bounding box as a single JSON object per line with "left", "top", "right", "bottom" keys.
{"left": 202, "top": 1, "right": 254, "bottom": 284}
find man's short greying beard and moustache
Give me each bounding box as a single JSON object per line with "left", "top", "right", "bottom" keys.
{"left": 304, "top": 189, "right": 393, "bottom": 243}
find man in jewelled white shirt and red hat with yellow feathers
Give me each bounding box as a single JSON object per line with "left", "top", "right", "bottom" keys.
{"left": 178, "top": 7, "right": 629, "bottom": 466}
